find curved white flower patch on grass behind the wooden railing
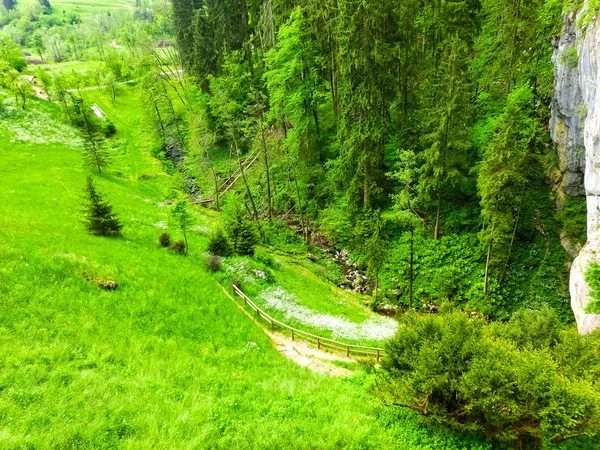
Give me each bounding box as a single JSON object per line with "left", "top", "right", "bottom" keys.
{"left": 259, "top": 286, "right": 398, "bottom": 341}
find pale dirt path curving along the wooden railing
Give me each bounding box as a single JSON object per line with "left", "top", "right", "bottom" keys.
{"left": 218, "top": 283, "right": 355, "bottom": 377}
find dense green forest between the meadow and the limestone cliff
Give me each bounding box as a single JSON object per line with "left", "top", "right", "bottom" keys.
{"left": 173, "top": 0, "right": 570, "bottom": 318}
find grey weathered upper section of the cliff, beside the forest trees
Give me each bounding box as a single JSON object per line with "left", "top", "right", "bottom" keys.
{"left": 550, "top": 13, "right": 586, "bottom": 196}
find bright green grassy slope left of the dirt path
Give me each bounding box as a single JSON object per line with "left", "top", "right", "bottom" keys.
{"left": 0, "top": 93, "right": 492, "bottom": 449}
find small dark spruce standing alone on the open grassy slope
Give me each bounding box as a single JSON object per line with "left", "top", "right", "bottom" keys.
{"left": 85, "top": 175, "right": 123, "bottom": 237}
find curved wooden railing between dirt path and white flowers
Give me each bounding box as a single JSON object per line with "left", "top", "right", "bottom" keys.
{"left": 232, "top": 285, "right": 384, "bottom": 362}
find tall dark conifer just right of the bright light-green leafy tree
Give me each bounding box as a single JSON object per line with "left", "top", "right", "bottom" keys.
{"left": 338, "top": 0, "right": 396, "bottom": 208}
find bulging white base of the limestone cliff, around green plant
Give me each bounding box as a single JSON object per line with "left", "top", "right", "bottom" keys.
{"left": 569, "top": 232, "right": 600, "bottom": 334}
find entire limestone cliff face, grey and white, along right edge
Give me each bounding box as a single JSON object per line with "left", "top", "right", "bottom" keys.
{"left": 550, "top": 7, "right": 600, "bottom": 334}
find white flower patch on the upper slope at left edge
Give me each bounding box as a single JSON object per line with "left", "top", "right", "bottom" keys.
{"left": 0, "top": 110, "right": 83, "bottom": 149}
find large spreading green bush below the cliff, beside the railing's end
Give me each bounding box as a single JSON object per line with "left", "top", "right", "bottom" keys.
{"left": 375, "top": 311, "right": 600, "bottom": 449}
